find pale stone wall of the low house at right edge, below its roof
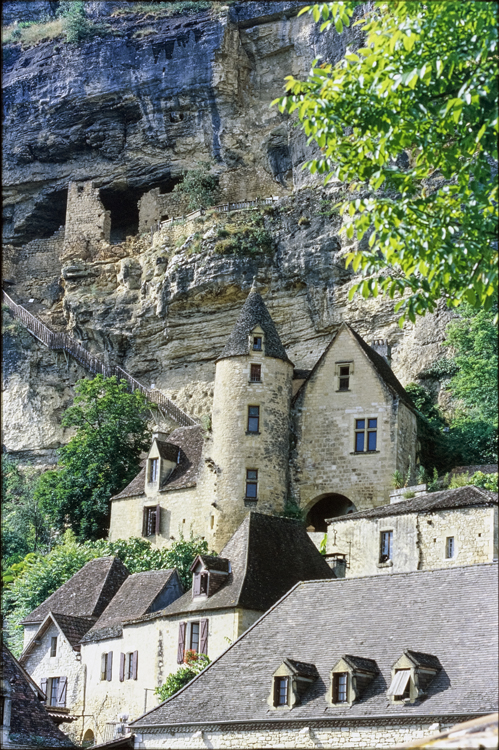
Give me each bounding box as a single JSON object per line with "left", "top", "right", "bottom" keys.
{"left": 327, "top": 507, "right": 497, "bottom": 578}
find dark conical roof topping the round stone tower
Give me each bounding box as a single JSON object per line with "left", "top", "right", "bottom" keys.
{"left": 217, "top": 290, "right": 290, "bottom": 362}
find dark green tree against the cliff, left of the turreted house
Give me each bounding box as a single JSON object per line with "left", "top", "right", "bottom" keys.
{"left": 35, "top": 375, "right": 149, "bottom": 541}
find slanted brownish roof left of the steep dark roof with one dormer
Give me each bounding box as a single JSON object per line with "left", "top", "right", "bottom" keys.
{"left": 81, "top": 568, "right": 182, "bottom": 643}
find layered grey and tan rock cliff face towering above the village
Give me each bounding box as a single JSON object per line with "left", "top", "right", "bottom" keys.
{"left": 0, "top": 2, "right": 449, "bottom": 461}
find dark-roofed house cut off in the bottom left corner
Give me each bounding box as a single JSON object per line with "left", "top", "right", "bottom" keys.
{"left": 0, "top": 644, "right": 74, "bottom": 750}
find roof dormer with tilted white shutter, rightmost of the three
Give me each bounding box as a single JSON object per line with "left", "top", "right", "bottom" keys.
{"left": 387, "top": 650, "right": 442, "bottom": 704}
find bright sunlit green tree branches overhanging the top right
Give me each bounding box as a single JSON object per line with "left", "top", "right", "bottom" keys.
{"left": 274, "top": 0, "right": 498, "bottom": 324}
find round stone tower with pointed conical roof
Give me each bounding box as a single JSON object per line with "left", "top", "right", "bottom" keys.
{"left": 212, "top": 289, "right": 293, "bottom": 549}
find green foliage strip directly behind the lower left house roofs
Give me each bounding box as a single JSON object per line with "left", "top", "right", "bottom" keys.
{"left": 2, "top": 529, "right": 209, "bottom": 654}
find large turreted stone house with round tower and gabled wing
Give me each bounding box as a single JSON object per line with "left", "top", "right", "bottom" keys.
{"left": 109, "top": 289, "right": 417, "bottom": 551}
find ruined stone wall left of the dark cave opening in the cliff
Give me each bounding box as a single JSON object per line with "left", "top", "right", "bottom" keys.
{"left": 64, "top": 181, "right": 111, "bottom": 260}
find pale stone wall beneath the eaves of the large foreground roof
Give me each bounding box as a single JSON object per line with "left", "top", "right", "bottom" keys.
{"left": 134, "top": 717, "right": 460, "bottom": 750}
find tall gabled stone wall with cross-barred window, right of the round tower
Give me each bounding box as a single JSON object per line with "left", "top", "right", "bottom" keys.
{"left": 293, "top": 329, "right": 416, "bottom": 510}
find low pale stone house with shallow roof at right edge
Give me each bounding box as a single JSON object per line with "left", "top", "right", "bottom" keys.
{"left": 327, "top": 486, "right": 498, "bottom": 578}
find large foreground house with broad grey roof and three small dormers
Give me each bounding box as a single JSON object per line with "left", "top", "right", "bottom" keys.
{"left": 130, "top": 563, "right": 497, "bottom": 750}
